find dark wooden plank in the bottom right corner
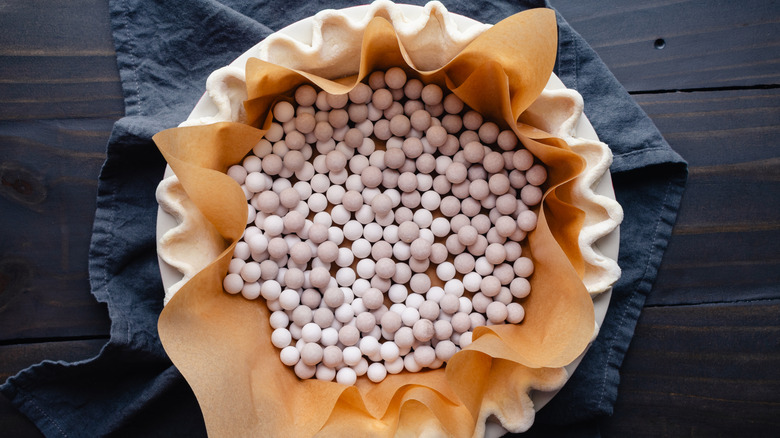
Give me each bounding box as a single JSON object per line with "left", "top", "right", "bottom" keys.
{"left": 604, "top": 300, "right": 780, "bottom": 437}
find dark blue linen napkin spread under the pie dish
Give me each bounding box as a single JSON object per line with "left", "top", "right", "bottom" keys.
{"left": 0, "top": 0, "right": 687, "bottom": 437}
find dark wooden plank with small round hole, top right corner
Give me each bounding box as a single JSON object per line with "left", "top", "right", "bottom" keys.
{"left": 551, "top": 0, "right": 780, "bottom": 92}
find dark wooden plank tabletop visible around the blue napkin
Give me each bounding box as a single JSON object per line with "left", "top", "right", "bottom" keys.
{"left": 0, "top": 0, "right": 780, "bottom": 437}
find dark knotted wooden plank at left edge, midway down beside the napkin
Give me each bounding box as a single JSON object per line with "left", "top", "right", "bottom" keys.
{"left": 0, "top": 119, "right": 113, "bottom": 342}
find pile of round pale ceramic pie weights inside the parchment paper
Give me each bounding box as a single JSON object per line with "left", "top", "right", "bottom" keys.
{"left": 223, "top": 68, "right": 547, "bottom": 385}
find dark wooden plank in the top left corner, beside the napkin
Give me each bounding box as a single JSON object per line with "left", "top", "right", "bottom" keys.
{"left": 0, "top": 0, "right": 124, "bottom": 120}
